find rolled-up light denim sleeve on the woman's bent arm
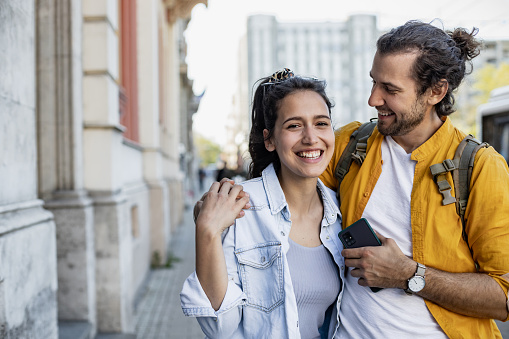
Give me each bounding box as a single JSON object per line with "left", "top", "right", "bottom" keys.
{"left": 180, "top": 226, "right": 246, "bottom": 338}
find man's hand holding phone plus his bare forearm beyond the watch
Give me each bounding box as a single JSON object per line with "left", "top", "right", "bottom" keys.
{"left": 341, "top": 233, "right": 509, "bottom": 321}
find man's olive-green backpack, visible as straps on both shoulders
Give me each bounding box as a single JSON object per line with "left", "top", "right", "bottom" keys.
{"left": 334, "top": 119, "right": 489, "bottom": 247}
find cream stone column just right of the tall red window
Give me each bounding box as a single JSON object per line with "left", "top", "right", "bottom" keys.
{"left": 137, "top": 0, "right": 171, "bottom": 263}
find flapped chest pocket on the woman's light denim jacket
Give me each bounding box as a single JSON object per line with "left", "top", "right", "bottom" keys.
{"left": 235, "top": 242, "right": 284, "bottom": 312}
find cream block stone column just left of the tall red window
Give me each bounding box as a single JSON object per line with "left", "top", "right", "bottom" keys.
{"left": 83, "top": 0, "right": 134, "bottom": 333}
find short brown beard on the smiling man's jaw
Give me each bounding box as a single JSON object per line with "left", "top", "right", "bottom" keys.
{"left": 376, "top": 98, "right": 426, "bottom": 136}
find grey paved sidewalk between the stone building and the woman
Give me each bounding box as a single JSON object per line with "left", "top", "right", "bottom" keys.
{"left": 136, "top": 208, "right": 204, "bottom": 339}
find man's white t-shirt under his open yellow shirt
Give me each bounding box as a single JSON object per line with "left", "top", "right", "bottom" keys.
{"left": 339, "top": 137, "right": 447, "bottom": 338}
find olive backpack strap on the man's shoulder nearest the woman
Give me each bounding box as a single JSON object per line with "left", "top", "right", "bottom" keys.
{"left": 334, "top": 119, "right": 376, "bottom": 206}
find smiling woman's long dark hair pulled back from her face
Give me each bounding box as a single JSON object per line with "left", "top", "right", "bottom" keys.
{"left": 249, "top": 71, "right": 333, "bottom": 178}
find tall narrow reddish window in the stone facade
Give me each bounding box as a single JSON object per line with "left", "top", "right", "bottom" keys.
{"left": 119, "top": 0, "right": 139, "bottom": 142}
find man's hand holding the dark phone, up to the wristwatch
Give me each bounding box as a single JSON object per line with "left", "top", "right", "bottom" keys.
{"left": 341, "top": 232, "right": 417, "bottom": 289}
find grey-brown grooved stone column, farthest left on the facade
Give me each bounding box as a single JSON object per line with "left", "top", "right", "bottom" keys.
{"left": 37, "top": 0, "right": 96, "bottom": 335}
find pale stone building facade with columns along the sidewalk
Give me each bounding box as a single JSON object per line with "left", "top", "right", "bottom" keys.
{"left": 0, "top": 0, "right": 206, "bottom": 338}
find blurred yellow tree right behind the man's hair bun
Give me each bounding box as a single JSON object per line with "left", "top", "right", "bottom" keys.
{"left": 451, "top": 62, "right": 509, "bottom": 135}
